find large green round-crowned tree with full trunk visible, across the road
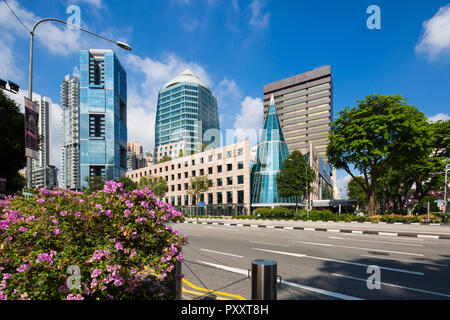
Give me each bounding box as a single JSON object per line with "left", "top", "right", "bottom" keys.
{"left": 327, "top": 94, "right": 432, "bottom": 215}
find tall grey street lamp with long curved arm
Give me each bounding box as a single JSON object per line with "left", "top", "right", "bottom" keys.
{"left": 27, "top": 18, "right": 131, "bottom": 188}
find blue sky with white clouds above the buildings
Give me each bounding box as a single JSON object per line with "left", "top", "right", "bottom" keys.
{"left": 0, "top": 0, "right": 450, "bottom": 196}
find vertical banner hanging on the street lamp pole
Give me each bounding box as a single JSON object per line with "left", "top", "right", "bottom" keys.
{"left": 25, "top": 97, "right": 39, "bottom": 160}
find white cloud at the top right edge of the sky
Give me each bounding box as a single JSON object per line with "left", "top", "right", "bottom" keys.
{"left": 415, "top": 4, "right": 450, "bottom": 60}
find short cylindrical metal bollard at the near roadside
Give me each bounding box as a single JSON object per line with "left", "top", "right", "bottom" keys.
{"left": 252, "top": 259, "right": 277, "bottom": 300}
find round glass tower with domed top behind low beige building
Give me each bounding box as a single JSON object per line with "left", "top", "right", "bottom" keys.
{"left": 155, "top": 69, "right": 220, "bottom": 162}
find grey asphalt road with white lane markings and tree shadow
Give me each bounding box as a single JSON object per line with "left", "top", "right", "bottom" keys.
{"left": 168, "top": 220, "right": 450, "bottom": 300}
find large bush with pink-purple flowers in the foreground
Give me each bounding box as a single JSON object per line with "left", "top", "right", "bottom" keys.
{"left": 0, "top": 181, "right": 186, "bottom": 300}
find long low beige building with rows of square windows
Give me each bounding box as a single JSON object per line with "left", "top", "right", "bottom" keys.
{"left": 126, "top": 140, "right": 251, "bottom": 215}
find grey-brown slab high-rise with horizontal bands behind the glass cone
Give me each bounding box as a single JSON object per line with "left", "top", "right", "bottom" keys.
{"left": 263, "top": 66, "right": 333, "bottom": 159}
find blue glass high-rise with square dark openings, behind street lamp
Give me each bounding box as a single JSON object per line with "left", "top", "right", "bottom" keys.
{"left": 80, "top": 49, "right": 127, "bottom": 189}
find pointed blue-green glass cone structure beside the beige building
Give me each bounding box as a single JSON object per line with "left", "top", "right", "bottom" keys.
{"left": 251, "top": 95, "right": 295, "bottom": 207}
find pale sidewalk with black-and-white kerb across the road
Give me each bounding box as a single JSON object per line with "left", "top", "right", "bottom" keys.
{"left": 184, "top": 217, "right": 450, "bottom": 239}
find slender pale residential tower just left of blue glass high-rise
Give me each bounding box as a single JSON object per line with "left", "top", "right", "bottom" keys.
{"left": 60, "top": 75, "right": 81, "bottom": 190}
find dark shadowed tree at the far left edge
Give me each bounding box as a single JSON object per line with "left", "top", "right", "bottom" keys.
{"left": 0, "top": 90, "right": 26, "bottom": 194}
